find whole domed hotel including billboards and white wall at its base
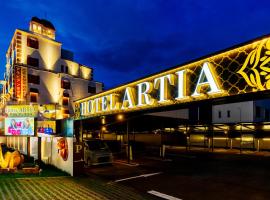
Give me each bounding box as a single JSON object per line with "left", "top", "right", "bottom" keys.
{"left": 0, "top": 17, "right": 103, "bottom": 175}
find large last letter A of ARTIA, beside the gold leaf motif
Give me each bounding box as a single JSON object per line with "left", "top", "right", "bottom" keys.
{"left": 191, "top": 62, "right": 221, "bottom": 97}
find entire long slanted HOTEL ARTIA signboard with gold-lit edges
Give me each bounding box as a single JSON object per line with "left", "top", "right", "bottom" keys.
{"left": 75, "top": 37, "right": 270, "bottom": 119}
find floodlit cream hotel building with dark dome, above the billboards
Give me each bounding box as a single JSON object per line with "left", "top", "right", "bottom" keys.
{"left": 1, "top": 17, "right": 103, "bottom": 116}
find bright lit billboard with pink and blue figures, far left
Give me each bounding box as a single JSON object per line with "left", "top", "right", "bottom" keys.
{"left": 5, "top": 117, "right": 35, "bottom": 135}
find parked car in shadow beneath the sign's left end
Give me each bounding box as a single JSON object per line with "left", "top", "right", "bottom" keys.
{"left": 84, "top": 139, "right": 113, "bottom": 166}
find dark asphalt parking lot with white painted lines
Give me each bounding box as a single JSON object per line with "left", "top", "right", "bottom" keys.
{"left": 86, "top": 151, "right": 270, "bottom": 200}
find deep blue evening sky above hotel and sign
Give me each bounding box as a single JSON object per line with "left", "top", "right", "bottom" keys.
{"left": 0, "top": 0, "right": 270, "bottom": 88}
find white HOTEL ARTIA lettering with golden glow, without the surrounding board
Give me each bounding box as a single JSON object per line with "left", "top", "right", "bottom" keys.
{"left": 77, "top": 62, "right": 223, "bottom": 116}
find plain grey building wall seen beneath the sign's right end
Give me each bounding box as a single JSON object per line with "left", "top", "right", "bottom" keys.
{"left": 212, "top": 101, "right": 254, "bottom": 123}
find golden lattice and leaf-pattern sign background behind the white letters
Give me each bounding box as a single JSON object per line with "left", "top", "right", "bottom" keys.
{"left": 75, "top": 37, "right": 270, "bottom": 119}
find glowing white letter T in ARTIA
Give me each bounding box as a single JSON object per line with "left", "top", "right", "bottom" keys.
{"left": 154, "top": 74, "right": 175, "bottom": 103}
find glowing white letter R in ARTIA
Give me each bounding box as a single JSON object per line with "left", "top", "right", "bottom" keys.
{"left": 137, "top": 82, "right": 154, "bottom": 106}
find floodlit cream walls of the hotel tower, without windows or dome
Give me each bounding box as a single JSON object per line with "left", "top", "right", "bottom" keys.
{"left": 2, "top": 27, "right": 103, "bottom": 116}
